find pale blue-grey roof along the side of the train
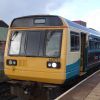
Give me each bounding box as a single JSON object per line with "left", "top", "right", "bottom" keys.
{"left": 65, "top": 19, "right": 100, "bottom": 37}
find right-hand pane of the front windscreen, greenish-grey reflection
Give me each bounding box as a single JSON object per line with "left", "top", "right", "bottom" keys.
{"left": 46, "top": 31, "right": 62, "bottom": 57}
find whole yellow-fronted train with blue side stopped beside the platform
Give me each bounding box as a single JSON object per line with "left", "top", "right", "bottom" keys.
{"left": 4, "top": 15, "right": 100, "bottom": 98}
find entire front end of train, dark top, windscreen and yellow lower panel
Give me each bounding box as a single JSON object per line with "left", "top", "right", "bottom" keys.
{"left": 4, "top": 15, "right": 67, "bottom": 84}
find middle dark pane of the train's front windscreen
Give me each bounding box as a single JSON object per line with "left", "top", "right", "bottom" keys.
{"left": 26, "top": 31, "right": 42, "bottom": 56}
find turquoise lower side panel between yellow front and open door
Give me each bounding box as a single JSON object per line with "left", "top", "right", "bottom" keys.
{"left": 66, "top": 59, "right": 80, "bottom": 79}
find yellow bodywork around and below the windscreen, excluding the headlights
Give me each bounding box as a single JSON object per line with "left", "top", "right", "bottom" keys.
{"left": 5, "top": 28, "right": 67, "bottom": 84}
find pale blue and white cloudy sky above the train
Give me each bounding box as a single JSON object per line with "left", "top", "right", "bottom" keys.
{"left": 0, "top": 0, "right": 100, "bottom": 31}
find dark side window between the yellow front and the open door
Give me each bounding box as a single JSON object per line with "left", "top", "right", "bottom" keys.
{"left": 71, "top": 32, "right": 80, "bottom": 51}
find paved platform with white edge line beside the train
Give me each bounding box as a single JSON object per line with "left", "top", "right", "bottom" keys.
{"left": 55, "top": 70, "right": 100, "bottom": 100}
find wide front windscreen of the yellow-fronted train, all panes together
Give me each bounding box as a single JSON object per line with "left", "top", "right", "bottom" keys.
{"left": 8, "top": 30, "right": 62, "bottom": 57}
